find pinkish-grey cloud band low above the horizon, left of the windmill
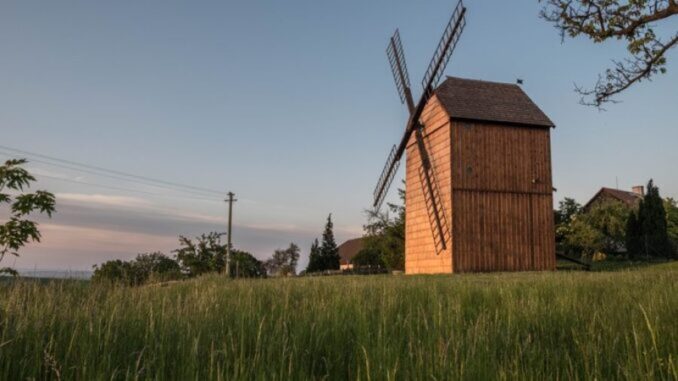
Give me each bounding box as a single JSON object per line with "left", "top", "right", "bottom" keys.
{"left": 8, "top": 189, "right": 361, "bottom": 270}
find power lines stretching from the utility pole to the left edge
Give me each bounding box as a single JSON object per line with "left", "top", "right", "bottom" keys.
{"left": 0, "top": 145, "right": 223, "bottom": 196}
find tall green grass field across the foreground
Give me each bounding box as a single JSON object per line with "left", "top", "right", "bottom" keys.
{"left": 0, "top": 263, "right": 678, "bottom": 380}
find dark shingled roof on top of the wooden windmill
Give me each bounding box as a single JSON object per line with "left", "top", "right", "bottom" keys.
{"left": 435, "top": 77, "right": 555, "bottom": 127}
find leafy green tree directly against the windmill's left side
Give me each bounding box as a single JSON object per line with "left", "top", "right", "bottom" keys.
{"left": 363, "top": 189, "right": 405, "bottom": 270}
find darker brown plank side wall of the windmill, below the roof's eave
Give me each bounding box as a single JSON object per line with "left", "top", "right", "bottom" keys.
{"left": 451, "top": 121, "right": 555, "bottom": 272}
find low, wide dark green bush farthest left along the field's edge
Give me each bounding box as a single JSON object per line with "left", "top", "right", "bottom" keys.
{"left": 92, "top": 252, "right": 182, "bottom": 286}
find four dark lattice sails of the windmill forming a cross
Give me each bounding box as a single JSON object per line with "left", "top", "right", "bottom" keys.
{"left": 373, "top": 0, "right": 466, "bottom": 252}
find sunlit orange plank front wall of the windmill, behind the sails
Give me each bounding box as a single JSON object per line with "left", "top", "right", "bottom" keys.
{"left": 405, "top": 97, "right": 452, "bottom": 274}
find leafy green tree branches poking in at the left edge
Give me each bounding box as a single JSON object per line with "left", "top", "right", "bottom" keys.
{"left": 0, "top": 159, "right": 56, "bottom": 275}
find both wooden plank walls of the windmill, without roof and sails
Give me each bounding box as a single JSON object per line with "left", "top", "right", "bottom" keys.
{"left": 405, "top": 97, "right": 555, "bottom": 274}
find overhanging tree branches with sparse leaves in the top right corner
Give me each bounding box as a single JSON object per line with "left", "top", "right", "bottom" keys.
{"left": 540, "top": 0, "right": 678, "bottom": 108}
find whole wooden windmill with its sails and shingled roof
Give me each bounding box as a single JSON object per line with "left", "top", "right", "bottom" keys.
{"left": 374, "top": 1, "right": 555, "bottom": 273}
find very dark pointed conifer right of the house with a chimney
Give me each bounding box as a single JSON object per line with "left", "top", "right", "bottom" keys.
{"left": 629, "top": 180, "right": 674, "bottom": 257}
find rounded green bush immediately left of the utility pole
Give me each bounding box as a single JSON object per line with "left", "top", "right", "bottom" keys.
{"left": 174, "top": 232, "right": 226, "bottom": 277}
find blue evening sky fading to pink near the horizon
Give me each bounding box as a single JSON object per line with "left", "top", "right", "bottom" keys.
{"left": 0, "top": 0, "right": 678, "bottom": 270}
